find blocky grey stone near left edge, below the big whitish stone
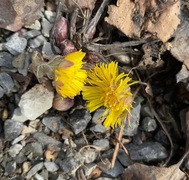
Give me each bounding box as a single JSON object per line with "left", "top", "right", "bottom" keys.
{"left": 4, "top": 119, "right": 23, "bottom": 141}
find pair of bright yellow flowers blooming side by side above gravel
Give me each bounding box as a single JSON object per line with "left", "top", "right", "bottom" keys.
{"left": 55, "top": 51, "right": 136, "bottom": 128}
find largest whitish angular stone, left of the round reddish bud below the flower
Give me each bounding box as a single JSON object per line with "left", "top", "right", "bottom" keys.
{"left": 19, "top": 84, "right": 54, "bottom": 120}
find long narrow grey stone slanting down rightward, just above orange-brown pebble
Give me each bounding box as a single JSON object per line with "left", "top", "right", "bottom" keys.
{"left": 33, "top": 132, "right": 62, "bottom": 146}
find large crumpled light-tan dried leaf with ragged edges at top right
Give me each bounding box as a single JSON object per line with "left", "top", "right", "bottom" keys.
{"left": 105, "top": 0, "right": 180, "bottom": 42}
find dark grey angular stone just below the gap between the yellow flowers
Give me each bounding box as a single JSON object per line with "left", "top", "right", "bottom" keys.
{"left": 69, "top": 109, "right": 91, "bottom": 134}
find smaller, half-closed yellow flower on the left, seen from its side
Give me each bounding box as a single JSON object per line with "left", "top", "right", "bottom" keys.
{"left": 55, "top": 51, "right": 87, "bottom": 98}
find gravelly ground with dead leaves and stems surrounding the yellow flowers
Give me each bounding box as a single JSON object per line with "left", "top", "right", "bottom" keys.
{"left": 0, "top": 0, "right": 189, "bottom": 180}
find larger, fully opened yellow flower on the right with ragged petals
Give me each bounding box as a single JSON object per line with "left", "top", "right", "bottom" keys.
{"left": 82, "top": 62, "right": 136, "bottom": 128}
